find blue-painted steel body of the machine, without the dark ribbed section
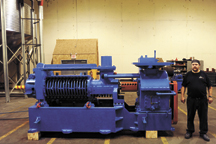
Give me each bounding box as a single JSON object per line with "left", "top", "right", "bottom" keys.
{"left": 26, "top": 50, "right": 175, "bottom": 134}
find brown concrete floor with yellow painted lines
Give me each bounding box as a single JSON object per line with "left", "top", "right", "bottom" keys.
{"left": 0, "top": 87, "right": 216, "bottom": 144}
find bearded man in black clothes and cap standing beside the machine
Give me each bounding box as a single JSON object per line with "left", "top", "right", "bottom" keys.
{"left": 181, "top": 60, "right": 213, "bottom": 141}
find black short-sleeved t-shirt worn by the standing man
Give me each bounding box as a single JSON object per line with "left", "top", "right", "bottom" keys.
{"left": 182, "top": 71, "right": 211, "bottom": 98}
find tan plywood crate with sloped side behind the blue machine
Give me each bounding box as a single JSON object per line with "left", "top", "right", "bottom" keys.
{"left": 52, "top": 39, "right": 99, "bottom": 79}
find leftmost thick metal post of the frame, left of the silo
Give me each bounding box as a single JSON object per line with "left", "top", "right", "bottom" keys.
{"left": 1, "top": 0, "right": 10, "bottom": 103}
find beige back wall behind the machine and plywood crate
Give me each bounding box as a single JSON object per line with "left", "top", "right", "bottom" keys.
{"left": 44, "top": 0, "right": 216, "bottom": 73}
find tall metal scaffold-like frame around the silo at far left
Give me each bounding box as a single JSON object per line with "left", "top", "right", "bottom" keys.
{"left": 0, "top": 0, "right": 44, "bottom": 103}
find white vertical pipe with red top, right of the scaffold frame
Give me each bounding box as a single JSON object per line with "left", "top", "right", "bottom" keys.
{"left": 38, "top": 0, "right": 45, "bottom": 63}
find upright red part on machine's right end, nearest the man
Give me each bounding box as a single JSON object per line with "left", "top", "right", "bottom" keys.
{"left": 170, "top": 81, "right": 178, "bottom": 124}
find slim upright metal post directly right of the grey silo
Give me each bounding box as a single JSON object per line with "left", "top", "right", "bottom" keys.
{"left": 20, "top": 4, "right": 28, "bottom": 98}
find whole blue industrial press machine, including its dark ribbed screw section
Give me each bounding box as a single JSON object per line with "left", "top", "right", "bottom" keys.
{"left": 25, "top": 52, "right": 176, "bottom": 134}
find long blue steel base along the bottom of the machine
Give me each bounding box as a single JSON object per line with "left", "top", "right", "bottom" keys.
{"left": 28, "top": 106, "right": 174, "bottom": 134}
